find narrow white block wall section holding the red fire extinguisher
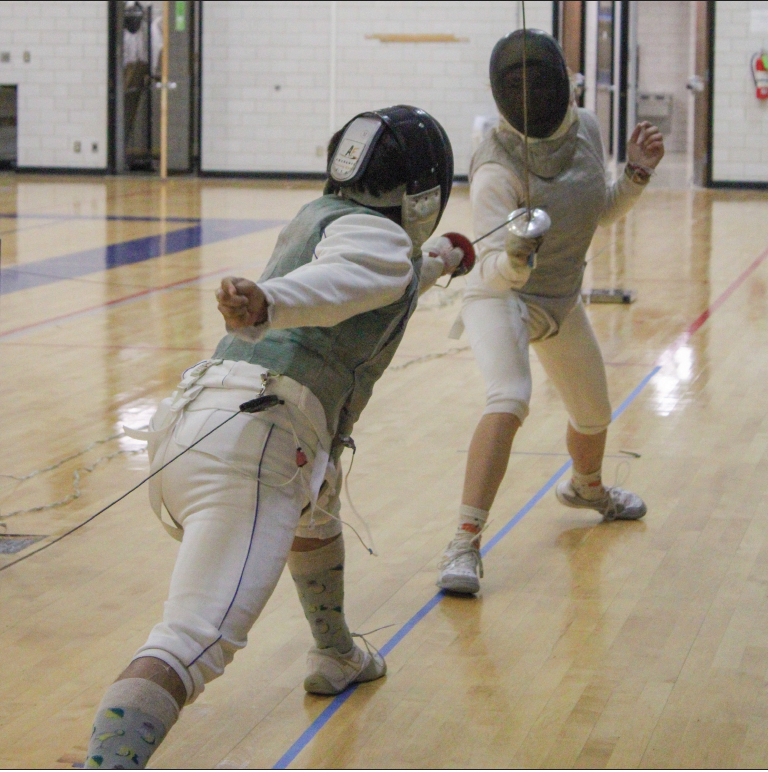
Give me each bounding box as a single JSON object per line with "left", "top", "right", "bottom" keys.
{"left": 712, "top": 1, "right": 768, "bottom": 182}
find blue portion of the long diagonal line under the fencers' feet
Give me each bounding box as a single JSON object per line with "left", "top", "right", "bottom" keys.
{"left": 272, "top": 367, "right": 661, "bottom": 769}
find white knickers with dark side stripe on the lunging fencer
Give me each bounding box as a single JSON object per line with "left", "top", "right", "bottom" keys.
{"left": 134, "top": 361, "right": 341, "bottom": 703}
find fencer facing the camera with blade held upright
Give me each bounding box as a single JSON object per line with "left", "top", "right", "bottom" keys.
{"left": 438, "top": 30, "right": 664, "bottom": 593}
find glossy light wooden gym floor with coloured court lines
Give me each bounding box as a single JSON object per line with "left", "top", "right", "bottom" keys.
{"left": 0, "top": 175, "right": 768, "bottom": 768}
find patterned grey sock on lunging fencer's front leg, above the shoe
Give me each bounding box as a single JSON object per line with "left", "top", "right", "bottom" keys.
{"left": 288, "top": 537, "right": 352, "bottom": 654}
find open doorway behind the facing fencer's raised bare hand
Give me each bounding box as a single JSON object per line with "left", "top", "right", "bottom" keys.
{"left": 557, "top": 0, "right": 714, "bottom": 187}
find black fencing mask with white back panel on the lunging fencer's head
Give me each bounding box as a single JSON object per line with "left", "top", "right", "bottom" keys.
{"left": 328, "top": 105, "right": 453, "bottom": 253}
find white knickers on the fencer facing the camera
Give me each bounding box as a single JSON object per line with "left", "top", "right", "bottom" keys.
{"left": 462, "top": 291, "right": 611, "bottom": 434}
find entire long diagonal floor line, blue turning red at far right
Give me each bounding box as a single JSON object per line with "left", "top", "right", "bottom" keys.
{"left": 272, "top": 244, "right": 768, "bottom": 769}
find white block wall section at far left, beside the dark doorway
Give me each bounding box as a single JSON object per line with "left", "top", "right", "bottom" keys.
{"left": 0, "top": 0, "right": 108, "bottom": 169}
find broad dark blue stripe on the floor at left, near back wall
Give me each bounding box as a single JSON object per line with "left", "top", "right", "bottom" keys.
{"left": 0, "top": 219, "right": 284, "bottom": 295}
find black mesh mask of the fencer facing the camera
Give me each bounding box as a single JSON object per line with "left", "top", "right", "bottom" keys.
{"left": 490, "top": 29, "right": 571, "bottom": 139}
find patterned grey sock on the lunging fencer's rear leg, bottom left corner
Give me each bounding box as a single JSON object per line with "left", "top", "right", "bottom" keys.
{"left": 85, "top": 678, "right": 180, "bottom": 769}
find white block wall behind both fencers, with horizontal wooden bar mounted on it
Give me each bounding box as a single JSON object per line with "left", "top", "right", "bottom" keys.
{"left": 202, "top": 0, "right": 552, "bottom": 174}
